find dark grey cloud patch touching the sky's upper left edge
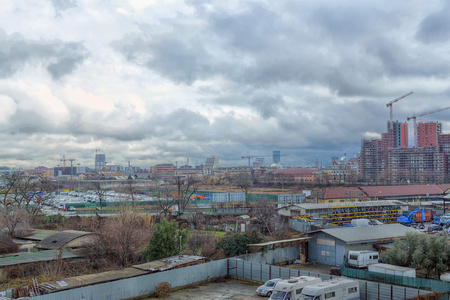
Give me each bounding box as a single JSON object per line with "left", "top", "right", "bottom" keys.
{"left": 0, "top": 30, "right": 89, "bottom": 80}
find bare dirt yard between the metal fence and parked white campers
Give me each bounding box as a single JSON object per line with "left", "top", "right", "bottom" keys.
{"left": 141, "top": 279, "right": 260, "bottom": 300}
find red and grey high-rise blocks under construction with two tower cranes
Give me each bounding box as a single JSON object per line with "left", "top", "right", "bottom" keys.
{"left": 359, "top": 92, "right": 450, "bottom": 185}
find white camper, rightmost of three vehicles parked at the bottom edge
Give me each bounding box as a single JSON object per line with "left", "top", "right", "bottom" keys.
{"left": 300, "top": 278, "right": 360, "bottom": 300}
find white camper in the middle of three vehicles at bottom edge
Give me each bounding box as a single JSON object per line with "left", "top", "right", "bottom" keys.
{"left": 269, "top": 276, "right": 322, "bottom": 300}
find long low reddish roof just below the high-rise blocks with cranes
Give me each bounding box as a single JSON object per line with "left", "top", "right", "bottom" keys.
{"left": 361, "top": 185, "right": 443, "bottom": 198}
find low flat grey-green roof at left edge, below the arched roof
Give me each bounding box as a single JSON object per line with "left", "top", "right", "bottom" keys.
{"left": 0, "top": 250, "right": 80, "bottom": 267}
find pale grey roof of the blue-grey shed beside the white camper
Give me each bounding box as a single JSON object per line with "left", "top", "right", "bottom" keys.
{"left": 320, "top": 224, "right": 419, "bottom": 244}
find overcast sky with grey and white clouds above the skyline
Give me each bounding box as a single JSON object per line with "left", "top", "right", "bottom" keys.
{"left": 0, "top": 0, "right": 450, "bottom": 168}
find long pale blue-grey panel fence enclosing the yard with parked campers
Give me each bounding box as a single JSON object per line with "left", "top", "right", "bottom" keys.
{"left": 29, "top": 258, "right": 431, "bottom": 300}
